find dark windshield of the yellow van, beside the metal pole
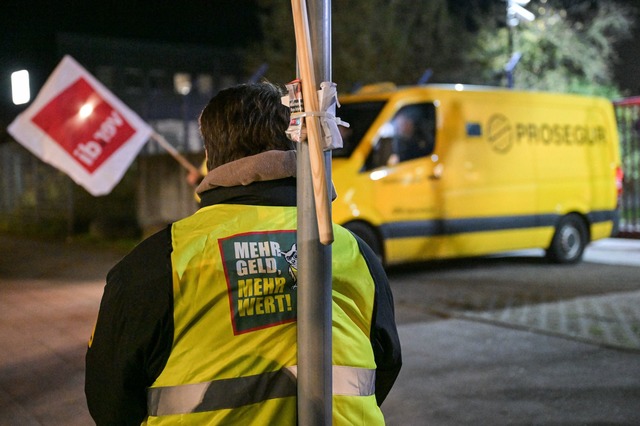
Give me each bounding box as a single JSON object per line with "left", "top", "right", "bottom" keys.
{"left": 331, "top": 101, "right": 385, "bottom": 158}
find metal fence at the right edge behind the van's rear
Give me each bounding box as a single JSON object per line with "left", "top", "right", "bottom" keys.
{"left": 615, "top": 96, "right": 640, "bottom": 238}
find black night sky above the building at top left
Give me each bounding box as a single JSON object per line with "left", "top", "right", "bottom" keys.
{"left": 0, "top": 0, "right": 258, "bottom": 49}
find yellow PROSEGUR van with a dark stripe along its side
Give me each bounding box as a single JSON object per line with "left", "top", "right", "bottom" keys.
{"left": 332, "top": 84, "right": 622, "bottom": 265}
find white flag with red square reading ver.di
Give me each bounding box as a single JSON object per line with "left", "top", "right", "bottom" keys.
{"left": 7, "top": 55, "right": 152, "bottom": 196}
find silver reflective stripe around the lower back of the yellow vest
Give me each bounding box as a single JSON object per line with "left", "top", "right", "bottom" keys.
{"left": 147, "top": 365, "right": 376, "bottom": 416}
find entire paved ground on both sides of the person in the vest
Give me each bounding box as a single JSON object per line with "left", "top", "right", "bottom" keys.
{"left": 0, "top": 236, "right": 640, "bottom": 426}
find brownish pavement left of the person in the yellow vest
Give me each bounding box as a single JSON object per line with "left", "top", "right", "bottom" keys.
{"left": 0, "top": 235, "right": 121, "bottom": 426}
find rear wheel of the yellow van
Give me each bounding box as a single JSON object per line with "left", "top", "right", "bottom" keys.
{"left": 547, "top": 214, "right": 589, "bottom": 263}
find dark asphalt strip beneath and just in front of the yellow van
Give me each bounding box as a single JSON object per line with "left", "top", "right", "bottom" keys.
{"left": 388, "top": 250, "right": 640, "bottom": 324}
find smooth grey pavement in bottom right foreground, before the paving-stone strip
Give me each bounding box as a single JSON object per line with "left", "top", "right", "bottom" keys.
{"left": 382, "top": 319, "right": 640, "bottom": 426}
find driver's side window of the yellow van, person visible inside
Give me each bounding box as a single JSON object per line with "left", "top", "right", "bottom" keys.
{"left": 365, "top": 103, "right": 436, "bottom": 169}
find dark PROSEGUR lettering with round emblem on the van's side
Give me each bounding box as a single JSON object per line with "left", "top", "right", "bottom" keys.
{"left": 487, "top": 114, "right": 607, "bottom": 154}
